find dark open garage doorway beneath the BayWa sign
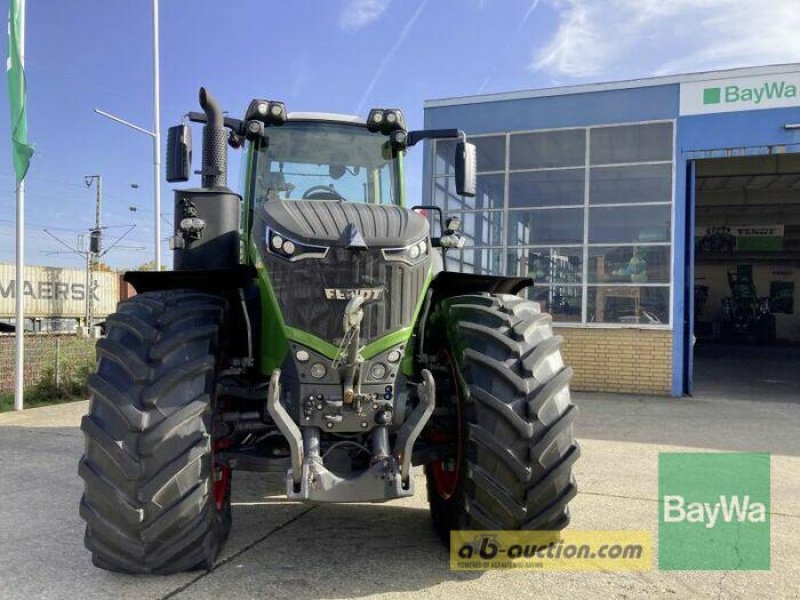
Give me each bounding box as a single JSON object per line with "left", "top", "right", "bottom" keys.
{"left": 693, "top": 154, "right": 800, "bottom": 402}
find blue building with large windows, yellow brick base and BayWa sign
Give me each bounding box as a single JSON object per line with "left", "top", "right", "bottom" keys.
{"left": 423, "top": 65, "right": 800, "bottom": 396}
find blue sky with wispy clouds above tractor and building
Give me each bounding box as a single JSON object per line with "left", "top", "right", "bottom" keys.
{"left": 0, "top": 0, "right": 800, "bottom": 269}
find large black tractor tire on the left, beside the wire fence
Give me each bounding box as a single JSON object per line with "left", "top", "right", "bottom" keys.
{"left": 79, "top": 290, "right": 231, "bottom": 574}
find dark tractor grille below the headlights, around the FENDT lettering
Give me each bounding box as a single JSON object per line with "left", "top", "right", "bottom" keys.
{"left": 262, "top": 247, "right": 430, "bottom": 344}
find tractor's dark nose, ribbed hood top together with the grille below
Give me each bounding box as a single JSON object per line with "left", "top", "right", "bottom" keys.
{"left": 252, "top": 200, "right": 431, "bottom": 346}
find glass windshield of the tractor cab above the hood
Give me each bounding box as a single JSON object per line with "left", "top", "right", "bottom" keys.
{"left": 252, "top": 121, "right": 401, "bottom": 206}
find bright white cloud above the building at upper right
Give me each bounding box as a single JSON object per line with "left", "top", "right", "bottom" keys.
{"left": 529, "top": 0, "right": 800, "bottom": 79}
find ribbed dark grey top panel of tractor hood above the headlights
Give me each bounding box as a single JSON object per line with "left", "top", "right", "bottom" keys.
{"left": 262, "top": 200, "right": 428, "bottom": 248}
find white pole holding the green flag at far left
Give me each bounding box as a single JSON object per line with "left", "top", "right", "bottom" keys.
{"left": 14, "top": 0, "right": 25, "bottom": 410}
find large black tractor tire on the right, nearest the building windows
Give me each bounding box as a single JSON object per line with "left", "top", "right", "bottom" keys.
{"left": 426, "top": 294, "right": 580, "bottom": 544}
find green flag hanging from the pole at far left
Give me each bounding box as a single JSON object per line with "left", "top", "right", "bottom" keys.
{"left": 6, "top": 0, "right": 33, "bottom": 183}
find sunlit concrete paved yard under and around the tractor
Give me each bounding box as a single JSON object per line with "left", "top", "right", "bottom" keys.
{"left": 0, "top": 394, "right": 800, "bottom": 600}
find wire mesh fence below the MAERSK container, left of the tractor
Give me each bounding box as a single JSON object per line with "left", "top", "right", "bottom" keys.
{"left": 0, "top": 333, "right": 96, "bottom": 394}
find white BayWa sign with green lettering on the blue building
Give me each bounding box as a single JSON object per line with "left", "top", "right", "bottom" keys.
{"left": 681, "top": 73, "right": 800, "bottom": 115}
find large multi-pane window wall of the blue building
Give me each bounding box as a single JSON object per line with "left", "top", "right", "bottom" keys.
{"left": 433, "top": 122, "right": 673, "bottom": 327}
